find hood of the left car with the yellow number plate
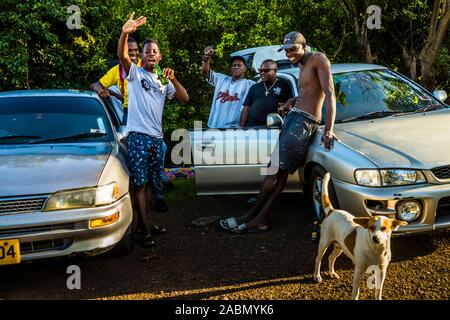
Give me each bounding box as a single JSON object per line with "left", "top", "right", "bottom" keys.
{"left": 0, "top": 143, "right": 112, "bottom": 197}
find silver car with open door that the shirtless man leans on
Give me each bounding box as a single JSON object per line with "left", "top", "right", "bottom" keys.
{"left": 190, "top": 46, "right": 450, "bottom": 233}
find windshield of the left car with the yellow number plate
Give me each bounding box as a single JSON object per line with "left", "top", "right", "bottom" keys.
{"left": 0, "top": 96, "right": 113, "bottom": 144}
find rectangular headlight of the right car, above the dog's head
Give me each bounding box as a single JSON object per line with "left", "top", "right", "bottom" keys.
{"left": 355, "top": 169, "right": 427, "bottom": 187}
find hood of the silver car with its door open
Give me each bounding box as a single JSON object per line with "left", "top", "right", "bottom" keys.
{"left": 334, "top": 109, "right": 450, "bottom": 169}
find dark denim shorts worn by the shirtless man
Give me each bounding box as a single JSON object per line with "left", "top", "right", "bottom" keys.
{"left": 271, "top": 108, "right": 320, "bottom": 174}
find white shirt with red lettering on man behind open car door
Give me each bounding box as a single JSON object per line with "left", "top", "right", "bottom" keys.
{"left": 206, "top": 70, "right": 255, "bottom": 128}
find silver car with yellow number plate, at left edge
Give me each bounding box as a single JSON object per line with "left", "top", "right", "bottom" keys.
{"left": 0, "top": 90, "right": 134, "bottom": 265}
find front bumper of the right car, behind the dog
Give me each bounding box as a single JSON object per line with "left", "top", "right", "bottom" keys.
{"left": 333, "top": 179, "right": 450, "bottom": 233}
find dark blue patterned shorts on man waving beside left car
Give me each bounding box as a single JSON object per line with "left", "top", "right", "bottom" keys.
{"left": 126, "top": 132, "right": 164, "bottom": 187}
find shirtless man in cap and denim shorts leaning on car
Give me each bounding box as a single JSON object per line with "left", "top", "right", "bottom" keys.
{"left": 219, "top": 31, "right": 336, "bottom": 233}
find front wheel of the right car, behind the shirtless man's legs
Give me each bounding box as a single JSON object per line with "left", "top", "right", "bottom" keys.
{"left": 307, "top": 166, "right": 339, "bottom": 222}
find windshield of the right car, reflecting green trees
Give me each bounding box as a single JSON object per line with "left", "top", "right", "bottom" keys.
{"left": 322, "top": 70, "right": 445, "bottom": 123}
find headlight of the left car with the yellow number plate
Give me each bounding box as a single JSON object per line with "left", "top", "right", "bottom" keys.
{"left": 44, "top": 182, "right": 119, "bottom": 211}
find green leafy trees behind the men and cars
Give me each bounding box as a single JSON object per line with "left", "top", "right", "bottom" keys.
{"left": 0, "top": 0, "right": 450, "bottom": 137}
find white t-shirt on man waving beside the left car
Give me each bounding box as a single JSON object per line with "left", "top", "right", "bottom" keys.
{"left": 124, "top": 63, "right": 176, "bottom": 138}
